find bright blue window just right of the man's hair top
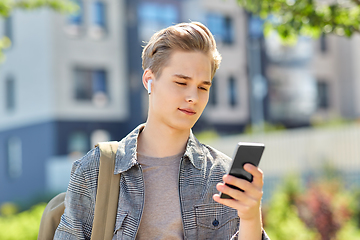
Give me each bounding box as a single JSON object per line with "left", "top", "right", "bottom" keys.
{"left": 206, "top": 13, "right": 234, "bottom": 44}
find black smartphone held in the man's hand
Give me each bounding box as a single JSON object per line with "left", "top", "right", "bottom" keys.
{"left": 220, "top": 142, "right": 265, "bottom": 199}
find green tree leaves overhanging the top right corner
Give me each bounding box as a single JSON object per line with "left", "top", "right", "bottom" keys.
{"left": 237, "top": 0, "right": 360, "bottom": 41}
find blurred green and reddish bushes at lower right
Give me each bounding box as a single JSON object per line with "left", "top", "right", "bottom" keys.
{"left": 263, "top": 172, "right": 360, "bottom": 240}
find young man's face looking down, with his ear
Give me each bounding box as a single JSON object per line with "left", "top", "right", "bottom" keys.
{"left": 144, "top": 51, "right": 211, "bottom": 130}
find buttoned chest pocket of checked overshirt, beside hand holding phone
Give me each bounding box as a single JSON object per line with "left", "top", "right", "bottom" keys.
{"left": 195, "top": 203, "right": 240, "bottom": 240}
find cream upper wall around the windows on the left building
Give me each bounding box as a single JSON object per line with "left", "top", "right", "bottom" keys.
{"left": 52, "top": 0, "right": 129, "bottom": 121}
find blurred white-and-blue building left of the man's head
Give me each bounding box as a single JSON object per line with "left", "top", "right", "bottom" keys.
{"left": 0, "top": 0, "right": 130, "bottom": 202}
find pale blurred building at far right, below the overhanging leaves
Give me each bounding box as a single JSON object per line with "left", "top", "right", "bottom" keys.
{"left": 265, "top": 35, "right": 360, "bottom": 126}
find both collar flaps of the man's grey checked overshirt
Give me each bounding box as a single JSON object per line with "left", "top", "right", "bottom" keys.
{"left": 114, "top": 124, "right": 204, "bottom": 174}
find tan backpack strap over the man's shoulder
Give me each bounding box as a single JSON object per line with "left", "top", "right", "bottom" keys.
{"left": 91, "top": 142, "right": 120, "bottom": 240}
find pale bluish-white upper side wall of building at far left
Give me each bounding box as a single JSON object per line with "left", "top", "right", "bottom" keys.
{"left": 0, "top": 9, "right": 53, "bottom": 130}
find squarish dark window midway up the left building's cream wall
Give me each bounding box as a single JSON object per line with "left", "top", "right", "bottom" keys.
{"left": 75, "top": 69, "right": 109, "bottom": 106}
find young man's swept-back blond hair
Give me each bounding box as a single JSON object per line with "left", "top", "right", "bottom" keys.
{"left": 141, "top": 22, "right": 221, "bottom": 78}
